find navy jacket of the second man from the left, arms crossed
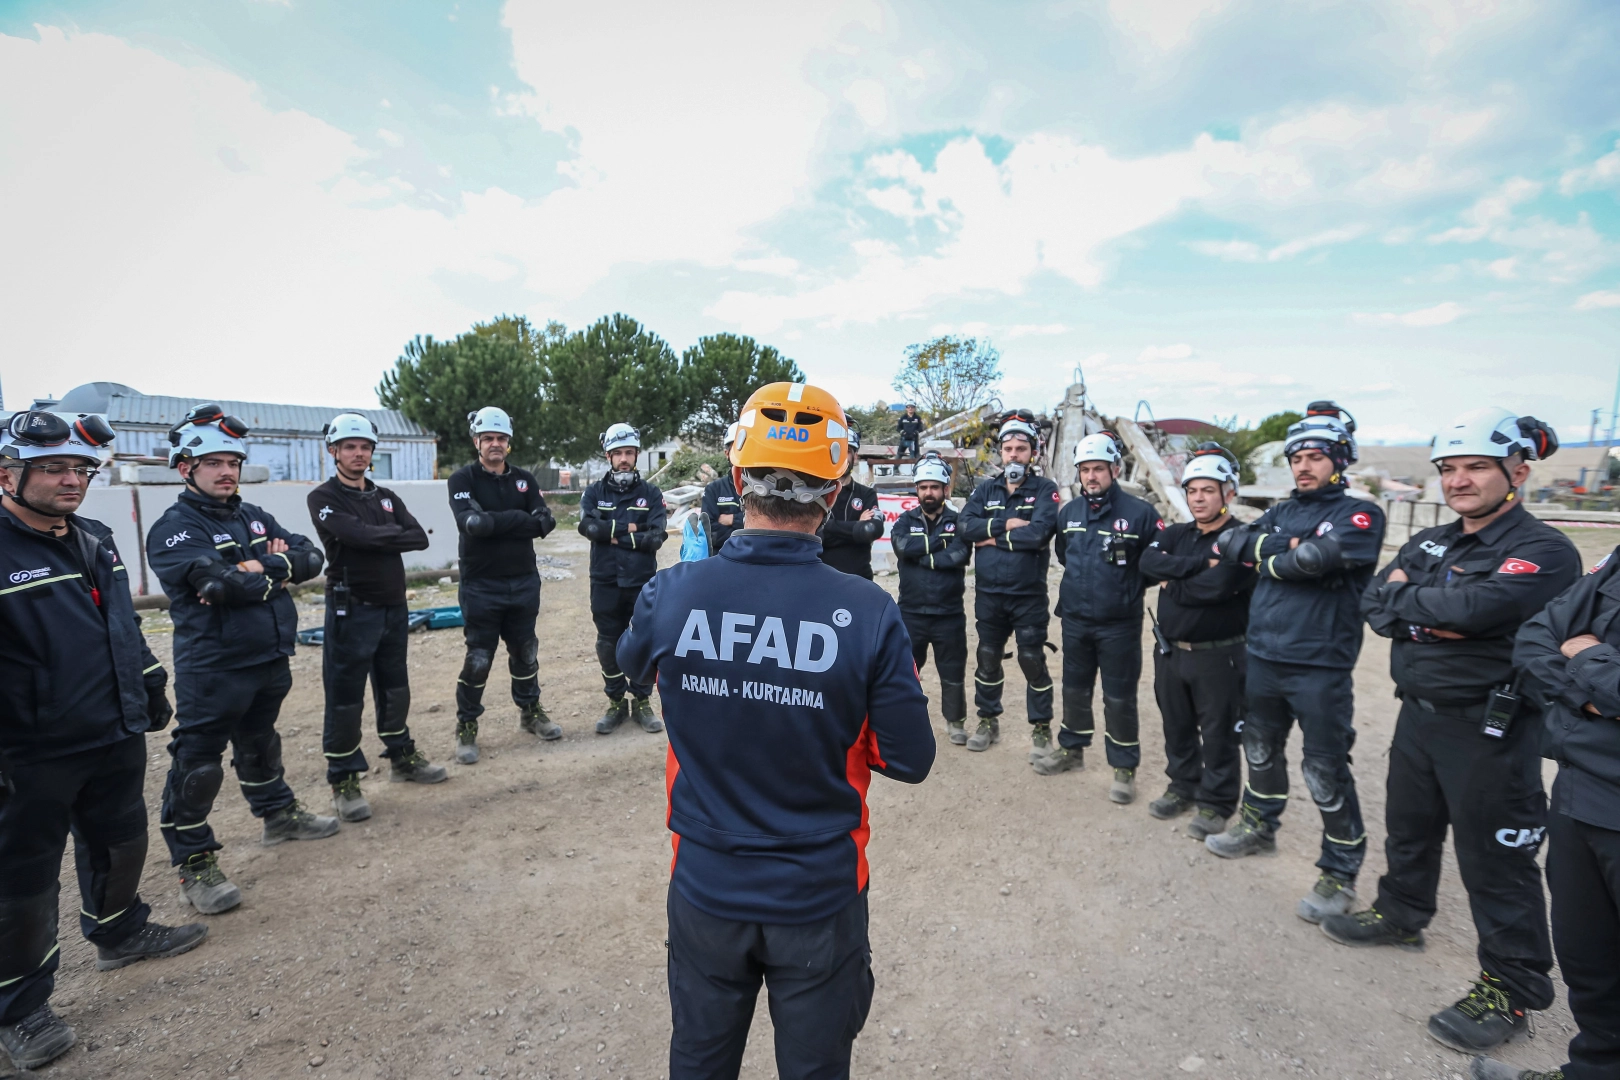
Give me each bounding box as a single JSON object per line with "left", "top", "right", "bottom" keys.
{"left": 146, "top": 487, "right": 314, "bottom": 675}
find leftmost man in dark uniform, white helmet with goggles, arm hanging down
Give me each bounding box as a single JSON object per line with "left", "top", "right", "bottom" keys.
{"left": 0, "top": 413, "right": 207, "bottom": 1069}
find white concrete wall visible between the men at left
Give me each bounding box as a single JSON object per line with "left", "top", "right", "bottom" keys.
{"left": 79, "top": 479, "right": 458, "bottom": 596}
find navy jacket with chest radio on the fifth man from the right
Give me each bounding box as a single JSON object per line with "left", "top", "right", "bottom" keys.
{"left": 1053, "top": 484, "right": 1165, "bottom": 622}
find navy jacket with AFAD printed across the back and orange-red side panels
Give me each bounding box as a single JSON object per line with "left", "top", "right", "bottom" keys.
{"left": 619, "top": 529, "right": 935, "bottom": 923}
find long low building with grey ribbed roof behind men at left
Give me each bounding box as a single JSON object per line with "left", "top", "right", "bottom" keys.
{"left": 34, "top": 382, "right": 437, "bottom": 481}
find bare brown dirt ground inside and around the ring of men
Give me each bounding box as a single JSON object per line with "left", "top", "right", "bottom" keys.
{"left": 28, "top": 531, "right": 1615, "bottom": 1080}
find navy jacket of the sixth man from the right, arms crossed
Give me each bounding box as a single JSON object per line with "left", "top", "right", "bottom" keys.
{"left": 956, "top": 476, "right": 1061, "bottom": 596}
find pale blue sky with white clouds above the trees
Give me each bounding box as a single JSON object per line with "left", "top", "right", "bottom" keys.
{"left": 0, "top": 0, "right": 1620, "bottom": 442}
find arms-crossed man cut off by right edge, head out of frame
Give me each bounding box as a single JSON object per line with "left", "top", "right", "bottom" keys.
{"left": 1509, "top": 549, "right": 1620, "bottom": 1080}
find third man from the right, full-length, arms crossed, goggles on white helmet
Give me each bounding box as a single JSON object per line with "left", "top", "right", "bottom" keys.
{"left": 1204, "top": 402, "right": 1383, "bottom": 923}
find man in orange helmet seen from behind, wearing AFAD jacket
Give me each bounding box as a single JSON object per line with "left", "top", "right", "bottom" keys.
{"left": 619, "top": 382, "right": 935, "bottom": 1080}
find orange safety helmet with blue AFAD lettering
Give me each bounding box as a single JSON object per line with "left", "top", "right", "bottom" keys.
{"left": 731, "top": 382, "right": 849, "bottom": 481}
